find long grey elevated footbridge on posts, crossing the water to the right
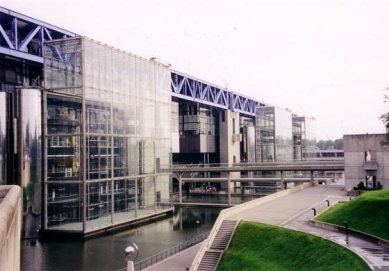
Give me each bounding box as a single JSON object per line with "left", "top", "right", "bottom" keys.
{"left": 173, "top": 160, "right": 344, "bottom": 206}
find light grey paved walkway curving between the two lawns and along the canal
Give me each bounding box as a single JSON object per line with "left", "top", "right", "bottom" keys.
{"left": 146, "top": 183, "right": 389, "bottom": 271}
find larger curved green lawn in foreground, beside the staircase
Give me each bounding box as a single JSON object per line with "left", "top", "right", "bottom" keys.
{"left": 217, "top": 222, "right": 370, "bottom": 271}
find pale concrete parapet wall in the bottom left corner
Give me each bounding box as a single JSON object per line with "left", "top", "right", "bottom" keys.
{"left": 0, "top": 185, "right": 22, "bottom": 271}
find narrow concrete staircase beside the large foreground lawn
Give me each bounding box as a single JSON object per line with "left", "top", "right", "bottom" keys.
{"left": 197, "top": 220, "right": 238, "bottom": 271}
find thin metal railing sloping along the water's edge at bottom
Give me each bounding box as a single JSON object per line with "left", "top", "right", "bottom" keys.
{"left": 119, "top": 232, "right": 209, "bottom": 271}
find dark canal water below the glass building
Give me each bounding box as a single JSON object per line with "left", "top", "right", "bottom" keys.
{"left": 21, "top": 207, "right": 222, "bottom": 271}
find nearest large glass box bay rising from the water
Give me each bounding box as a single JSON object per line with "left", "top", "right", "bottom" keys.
{"left": 42, "top": 37, "right": 172, "bottom": 235}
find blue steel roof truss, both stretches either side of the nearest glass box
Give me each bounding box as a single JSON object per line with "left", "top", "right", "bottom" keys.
{"left": 0, "top": 7, "right": 266, "bottom": 117}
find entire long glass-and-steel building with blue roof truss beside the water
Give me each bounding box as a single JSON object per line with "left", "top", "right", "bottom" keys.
{"left": 0, "top": 7, "right": 315, "bottom": 238}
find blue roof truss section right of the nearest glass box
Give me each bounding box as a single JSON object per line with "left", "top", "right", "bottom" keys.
{"left": 171, "top": 70, "right": 267, "bottom": 116}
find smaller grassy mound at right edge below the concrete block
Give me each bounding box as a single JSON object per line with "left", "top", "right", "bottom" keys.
{"left": 315, "top": 190, "right": 389, "bottom": 240}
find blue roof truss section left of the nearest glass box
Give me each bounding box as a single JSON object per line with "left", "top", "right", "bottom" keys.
{"left": 0, "top": 7, "right": 77, "bottom": 63}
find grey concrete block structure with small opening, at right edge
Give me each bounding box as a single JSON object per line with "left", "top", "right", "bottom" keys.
{"left": 343, "top": 134, "right": 389, "bottom": 189}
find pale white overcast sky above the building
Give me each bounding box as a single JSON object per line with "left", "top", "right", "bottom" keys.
{"left": 0, "top": 0, "right": 389, "bottom": 140}
